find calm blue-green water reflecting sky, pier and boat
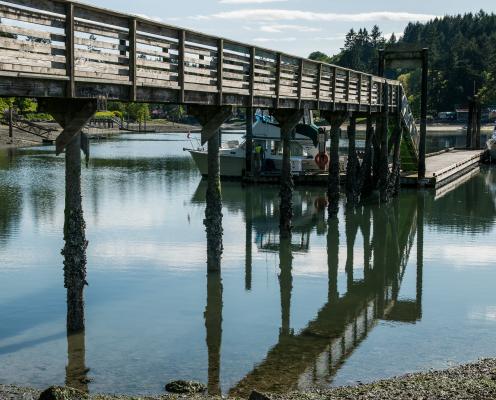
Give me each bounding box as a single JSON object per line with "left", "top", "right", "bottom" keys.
{"left": 0, "top": 135, "right": 496, "bottom": 395}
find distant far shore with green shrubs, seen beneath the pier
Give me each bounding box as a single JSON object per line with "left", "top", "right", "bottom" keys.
{"left": 0, "top": 120, "right": 493, "bottom": 149}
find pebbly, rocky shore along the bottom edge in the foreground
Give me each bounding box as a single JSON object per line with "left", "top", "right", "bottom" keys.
{"left": 0, "top": 359, "right": 496, "bottom": 400}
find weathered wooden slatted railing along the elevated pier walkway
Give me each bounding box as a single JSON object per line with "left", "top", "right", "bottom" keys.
{"left": 0, "top": 0, "right": 400, "bottom": 112}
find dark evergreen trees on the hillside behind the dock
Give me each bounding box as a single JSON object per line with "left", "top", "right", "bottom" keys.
{"left": 309, "top": 11, "right": 496, "bottom": 115}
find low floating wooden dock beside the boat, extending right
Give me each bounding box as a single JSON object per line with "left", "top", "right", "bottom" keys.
{"left": 243, "top": 149, "right": 484, "bottom": 189}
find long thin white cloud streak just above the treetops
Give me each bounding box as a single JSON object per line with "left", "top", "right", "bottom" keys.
{"left": 196, "top": 9, "right": 436, "bottom": 22}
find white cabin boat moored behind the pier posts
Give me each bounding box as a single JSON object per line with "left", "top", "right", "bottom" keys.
{"left": 185, "top": 118, "right": 327, "bottom": 178}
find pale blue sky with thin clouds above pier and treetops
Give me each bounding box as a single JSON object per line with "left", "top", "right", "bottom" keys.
{"left": 85, "top": 0, "right": 496, "bottom": 56}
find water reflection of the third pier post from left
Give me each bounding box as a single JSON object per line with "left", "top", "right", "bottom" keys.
{"left": 279, "top": 236, "right": 293, "bottom": 336}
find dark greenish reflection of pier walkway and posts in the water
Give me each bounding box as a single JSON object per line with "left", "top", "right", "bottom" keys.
{"left": 230, "top": 195, "right": 423, "bottom": 396}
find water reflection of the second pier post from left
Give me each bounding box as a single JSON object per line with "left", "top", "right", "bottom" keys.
{"left": 204, "top": 268, "right": 222, "bottom": 396}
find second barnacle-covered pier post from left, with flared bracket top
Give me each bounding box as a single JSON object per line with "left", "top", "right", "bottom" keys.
{"left": 188, "top": 105, "right": 232, "bottom": 271}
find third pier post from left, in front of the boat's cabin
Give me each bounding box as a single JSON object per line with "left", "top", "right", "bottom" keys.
{"left": 272, "top": 109, "right": 303, "bottom": 238}
